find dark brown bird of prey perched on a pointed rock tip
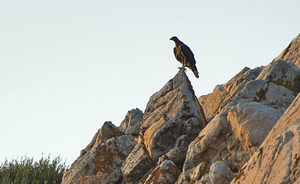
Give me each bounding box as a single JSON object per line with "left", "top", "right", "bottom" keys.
{"left": 170, "top": 36, "right": 199, "bottom": 78}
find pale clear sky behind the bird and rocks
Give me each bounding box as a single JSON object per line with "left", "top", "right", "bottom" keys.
{"left": 0, "top": 0, "right": 300, "bottom": 165}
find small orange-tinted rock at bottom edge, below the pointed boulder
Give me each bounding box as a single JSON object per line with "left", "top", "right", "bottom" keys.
{"left": 143, "top": 160, "right": 180, "bottom": 184}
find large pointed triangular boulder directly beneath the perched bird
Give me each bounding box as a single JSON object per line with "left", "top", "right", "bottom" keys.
{"left": 140, "top": 70, "right": 206, "bottom": 163}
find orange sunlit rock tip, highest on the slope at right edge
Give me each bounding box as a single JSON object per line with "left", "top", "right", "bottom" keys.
{"left": 273, "top": 34, "right": 300, "bottom": 67}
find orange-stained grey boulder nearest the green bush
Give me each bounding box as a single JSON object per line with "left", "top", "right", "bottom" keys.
{"left": 62, "top": 122, "right": 136, "bottom": 184}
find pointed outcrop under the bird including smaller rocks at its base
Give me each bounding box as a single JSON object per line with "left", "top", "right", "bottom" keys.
{"left": 122, "top": 71, "right": 206, "bottom": 183}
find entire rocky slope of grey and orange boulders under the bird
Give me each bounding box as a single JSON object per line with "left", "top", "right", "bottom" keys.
{"left": 62, "top": 35, "right": 300, "bottom": 184}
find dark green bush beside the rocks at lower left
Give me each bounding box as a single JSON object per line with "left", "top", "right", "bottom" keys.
{"left": 0, "top": 155, "right": 67, "bottom": 184}
